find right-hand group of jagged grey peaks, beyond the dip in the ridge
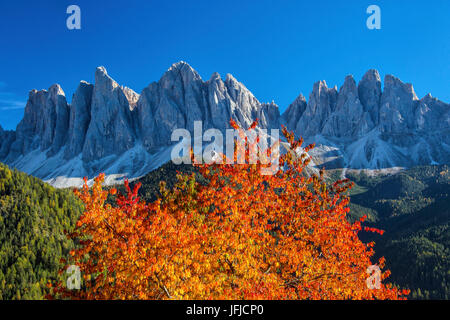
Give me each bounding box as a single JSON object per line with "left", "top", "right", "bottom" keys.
{"left": 283, "top": 70, "right": 450, "bottom": 169}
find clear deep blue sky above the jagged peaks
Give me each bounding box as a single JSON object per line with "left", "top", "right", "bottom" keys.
{"left": 0, "top": 0, "right": 450, "bottom": 129}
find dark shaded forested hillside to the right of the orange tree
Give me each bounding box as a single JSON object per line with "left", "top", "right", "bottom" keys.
{"left": 350, "top": 165, "right": 450, "bottom": 299}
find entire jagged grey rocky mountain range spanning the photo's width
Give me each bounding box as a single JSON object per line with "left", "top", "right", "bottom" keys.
{"left": 0, "top": 62, "right": 450, "bottom": 187}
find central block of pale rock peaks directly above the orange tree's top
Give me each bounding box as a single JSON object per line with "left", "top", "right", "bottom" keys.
{"left": 136, "top": 62, "right": 280, "bottom": 152}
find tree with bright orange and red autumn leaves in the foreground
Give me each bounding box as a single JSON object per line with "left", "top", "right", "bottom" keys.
{"left": 55, "top": 122, "right": 407, "bottom": 299}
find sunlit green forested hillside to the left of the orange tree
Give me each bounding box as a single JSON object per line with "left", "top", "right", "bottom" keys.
{"left": 0, "top": 164, "right": 82, "bottom": 299}
